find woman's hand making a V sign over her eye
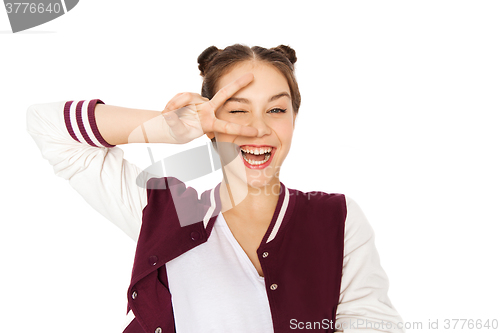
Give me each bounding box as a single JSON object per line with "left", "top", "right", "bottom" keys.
{"left": 162, "top": 73, "right": 258, "bottom": 143}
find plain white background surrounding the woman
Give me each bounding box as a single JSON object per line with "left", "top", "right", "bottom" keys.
{"left": 0, "top": 0, "right": 500, "bottom": 333}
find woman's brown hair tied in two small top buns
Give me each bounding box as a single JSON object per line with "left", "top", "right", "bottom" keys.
{"left": 198, "top": 44, "right": 300, "bottom": 142}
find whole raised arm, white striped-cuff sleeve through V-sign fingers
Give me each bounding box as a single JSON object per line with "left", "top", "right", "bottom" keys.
{"left": 26, "top": 74, "right": 257, "bottom": 240}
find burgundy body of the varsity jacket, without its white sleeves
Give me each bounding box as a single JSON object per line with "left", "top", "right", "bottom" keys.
{"left": 124, "top": 177, "right": 347, "bottom": 333}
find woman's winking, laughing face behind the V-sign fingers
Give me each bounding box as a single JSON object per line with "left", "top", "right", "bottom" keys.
{"left": 215, "top": 61, "right": 296, "bottom": 188}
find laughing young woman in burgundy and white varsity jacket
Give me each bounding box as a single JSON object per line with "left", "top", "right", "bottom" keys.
{"left": 28, "top": 44, "right": 403, "bottom": 333}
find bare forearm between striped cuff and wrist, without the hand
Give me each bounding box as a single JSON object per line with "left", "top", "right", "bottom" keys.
{"left": 95, "top": 104, "right": 163, "bottom": 145}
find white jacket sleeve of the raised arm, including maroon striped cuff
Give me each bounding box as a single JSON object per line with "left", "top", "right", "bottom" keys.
{"left": 26, "top": 99, "right": 147, "bottom": 241}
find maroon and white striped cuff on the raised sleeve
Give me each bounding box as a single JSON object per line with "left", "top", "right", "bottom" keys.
{"left": 64, "top": 99, "right": 114, "bottom": 147}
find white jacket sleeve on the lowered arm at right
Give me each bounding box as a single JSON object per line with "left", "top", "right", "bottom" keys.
{"left": 335, "top": 196, "right": 404, "bottom": 333}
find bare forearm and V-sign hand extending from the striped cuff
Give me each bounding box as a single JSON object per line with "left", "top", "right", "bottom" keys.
{"left": 95, "top": 74, "right": 258, "bottom": 145}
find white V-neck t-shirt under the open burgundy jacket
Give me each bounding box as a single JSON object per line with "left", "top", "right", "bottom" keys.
{"left": 166, "top": 214, "right": 273, "bottom": 333}
